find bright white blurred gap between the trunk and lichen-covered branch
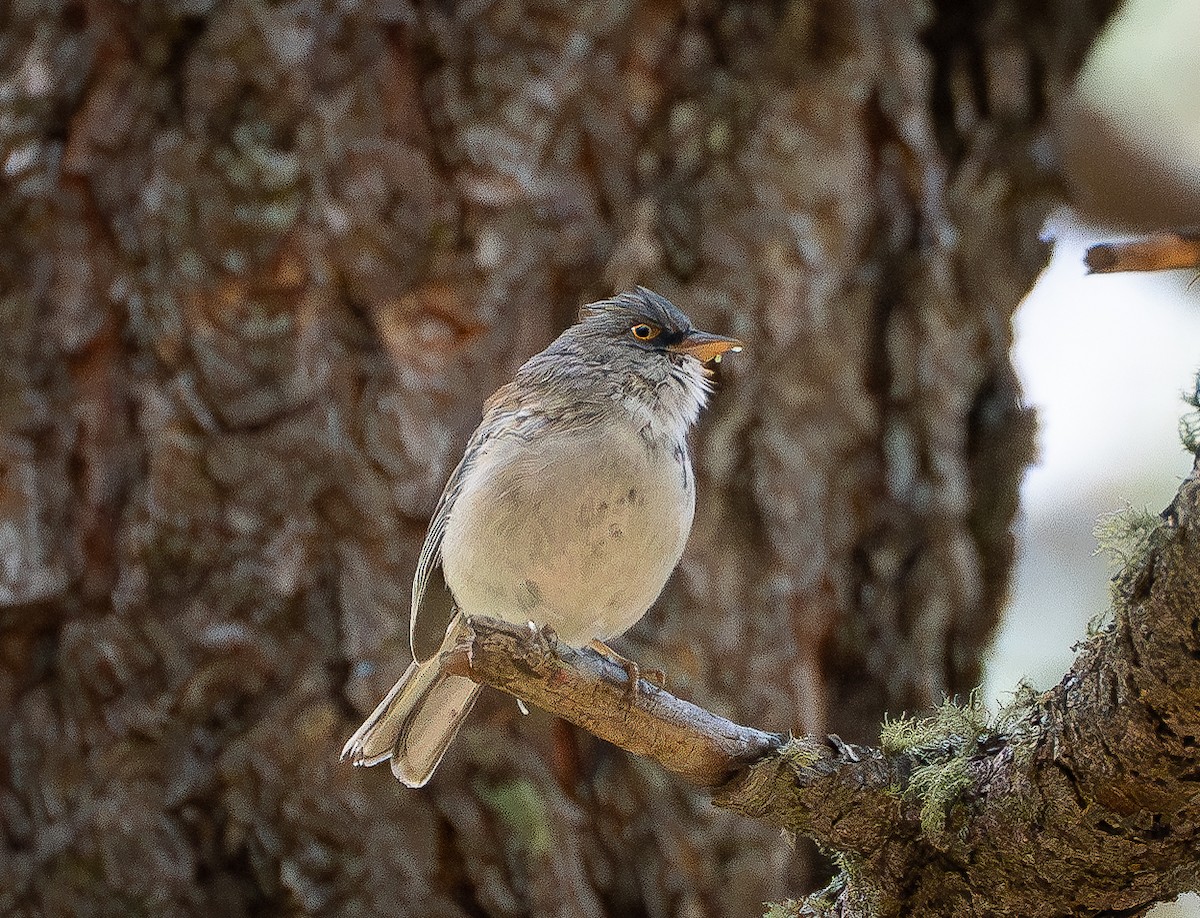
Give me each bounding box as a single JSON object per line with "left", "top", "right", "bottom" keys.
{"left": 986, "top": 224, "right": 1200, "bottom": 700}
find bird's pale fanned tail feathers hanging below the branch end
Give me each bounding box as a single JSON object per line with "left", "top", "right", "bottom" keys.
{"left": 342, "top": 617, "right": 480, "bottom": 787}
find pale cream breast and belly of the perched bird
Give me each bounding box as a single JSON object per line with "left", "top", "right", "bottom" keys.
{"left": 442, "top": 422, "right": 695, "bottom": 644}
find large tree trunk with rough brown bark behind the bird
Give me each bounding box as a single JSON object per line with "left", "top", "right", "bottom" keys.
{"left": 0, "top": 0, "right": 1112, "bottom": 916}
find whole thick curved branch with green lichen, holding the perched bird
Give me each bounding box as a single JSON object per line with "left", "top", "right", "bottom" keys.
{"left": 443, "top": 453, "right": 1200, "bottom": 918}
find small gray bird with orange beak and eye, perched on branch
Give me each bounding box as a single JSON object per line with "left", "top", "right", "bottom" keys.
{"left": 342, "top": 287, "right": 742, "bottom": 787}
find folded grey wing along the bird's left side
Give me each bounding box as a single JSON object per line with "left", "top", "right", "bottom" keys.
{"left": 408, "top": 383, "right": 544, "bottom": 662}
